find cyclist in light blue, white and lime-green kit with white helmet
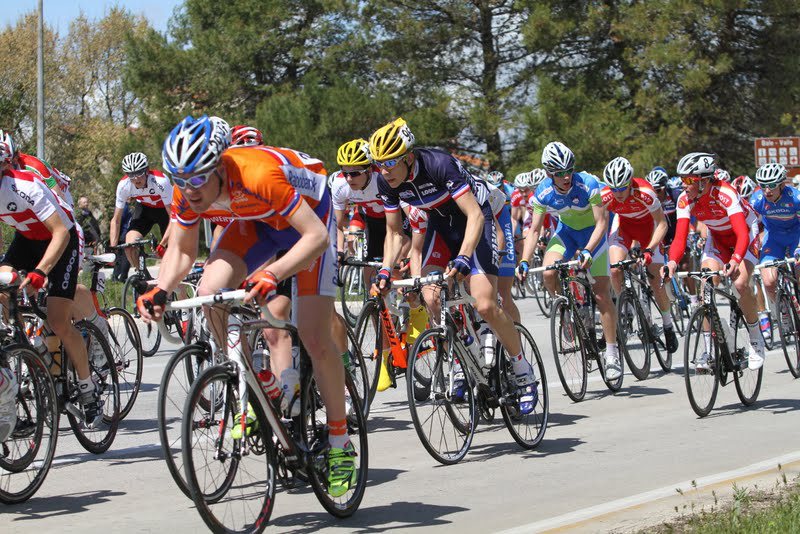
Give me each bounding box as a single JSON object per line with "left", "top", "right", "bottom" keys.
{"left": 518, "top": 141, "right": 622, "bottom": 380}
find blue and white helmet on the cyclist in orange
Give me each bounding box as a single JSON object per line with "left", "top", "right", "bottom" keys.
{"left": 161, "top": 115, "right": 231, "bottom": 174}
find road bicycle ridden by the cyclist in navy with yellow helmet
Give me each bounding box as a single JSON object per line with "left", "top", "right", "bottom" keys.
{"left": 404, "top": 273, "right": 550, "bottom": 465}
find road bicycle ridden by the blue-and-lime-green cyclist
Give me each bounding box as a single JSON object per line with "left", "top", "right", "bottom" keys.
{"left": 538, "top": 260, "right": 630, "bottom": 402}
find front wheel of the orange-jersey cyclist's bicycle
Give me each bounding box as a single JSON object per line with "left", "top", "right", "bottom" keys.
{"left": 181, "top": 364, "right": 276, "bottom": 533}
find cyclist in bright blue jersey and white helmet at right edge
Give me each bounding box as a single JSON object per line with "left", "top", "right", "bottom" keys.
{"left": 750, "top": 163, "right": 800, "bottom": 308}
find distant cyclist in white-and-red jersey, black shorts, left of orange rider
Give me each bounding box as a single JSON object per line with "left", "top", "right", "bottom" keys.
{"left": 109, "top": 152, "right": 172, "bottom": 265}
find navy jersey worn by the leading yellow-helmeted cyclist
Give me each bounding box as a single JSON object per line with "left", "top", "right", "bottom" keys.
{"left": 378, "top": 148, "right": 489, "bottom": 217}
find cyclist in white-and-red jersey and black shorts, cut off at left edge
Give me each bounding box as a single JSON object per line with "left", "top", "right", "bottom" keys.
{"left": 0, "top": 138, "right": 103, "bottom": 428}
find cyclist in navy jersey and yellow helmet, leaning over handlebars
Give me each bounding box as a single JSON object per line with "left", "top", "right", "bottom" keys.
{"left": 369, "top": 118, "right": 538, "bottom": 414}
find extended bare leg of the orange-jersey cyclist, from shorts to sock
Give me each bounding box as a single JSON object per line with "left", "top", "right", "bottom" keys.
{"left": 297, "top": 295, "right": 345, "bottom": 421}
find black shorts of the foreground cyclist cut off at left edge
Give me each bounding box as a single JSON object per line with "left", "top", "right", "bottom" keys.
{"left": 3, "top": 226, "right": 80, "bottom": 300}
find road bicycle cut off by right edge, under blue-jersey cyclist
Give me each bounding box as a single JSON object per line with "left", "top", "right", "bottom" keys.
{"left": 757, "top": 258, "right": 800, "bottom": 378}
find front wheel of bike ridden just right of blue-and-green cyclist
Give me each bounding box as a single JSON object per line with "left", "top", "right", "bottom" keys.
{"left": 617, "top": 289, "right": 653, "bottom": 380}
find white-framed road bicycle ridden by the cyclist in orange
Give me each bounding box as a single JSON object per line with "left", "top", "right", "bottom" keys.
{"left": 162, "top": 290, "right": 368, "bottom": 532}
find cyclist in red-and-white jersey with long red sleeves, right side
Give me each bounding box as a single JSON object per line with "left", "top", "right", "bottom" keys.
{"left": 665, "top": 152, "right": 764, "bottom": 370}
